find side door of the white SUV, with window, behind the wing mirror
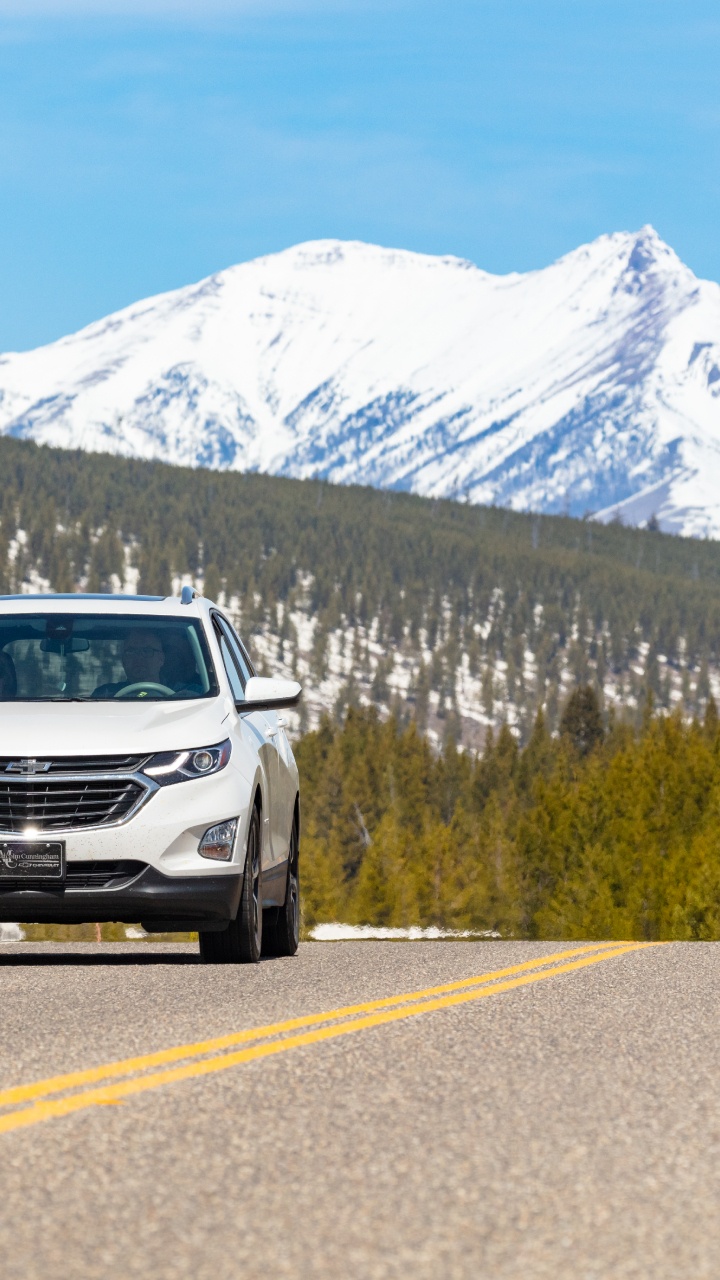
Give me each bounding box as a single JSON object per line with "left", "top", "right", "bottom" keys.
{"left": 213, "top": 613, "right": 287, "bottom": 881}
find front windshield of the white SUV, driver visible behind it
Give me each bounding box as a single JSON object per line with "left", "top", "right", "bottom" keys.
{"left": 0, "top": 613, "right": 218, "bottom": 701}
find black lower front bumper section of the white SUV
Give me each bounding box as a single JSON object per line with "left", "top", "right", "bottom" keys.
{"left": 0, "top": 865, "right": 242, "bottom": 933}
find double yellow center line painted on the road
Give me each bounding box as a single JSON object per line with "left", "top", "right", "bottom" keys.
{"left": 0, "top": 942, "right": 657, "bottom": 1133}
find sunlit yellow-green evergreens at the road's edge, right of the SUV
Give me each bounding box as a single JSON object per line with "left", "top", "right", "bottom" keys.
{"left": 297, "top": 685, "right": 720, "bottom": 941}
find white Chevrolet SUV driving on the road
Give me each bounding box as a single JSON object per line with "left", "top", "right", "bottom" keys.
{"left": 0, "top": 588, "right": 301, "bottom": 963}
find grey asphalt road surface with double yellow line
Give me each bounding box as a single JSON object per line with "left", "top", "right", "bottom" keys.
{"left": 0, "top": 942, "right": 720, "bottom": 1280}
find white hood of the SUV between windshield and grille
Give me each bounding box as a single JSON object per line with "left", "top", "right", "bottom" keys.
{"left": 0, "top": 696, "right": 232, "bottom": 759}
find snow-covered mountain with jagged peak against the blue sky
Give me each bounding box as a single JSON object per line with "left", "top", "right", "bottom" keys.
{"left": 0, "top": 227, "right": 720, "bottom": 535}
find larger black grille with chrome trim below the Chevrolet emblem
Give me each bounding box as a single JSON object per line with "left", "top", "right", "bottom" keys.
{"left": 0, "top": 773, "right": 147, "bottom": 832}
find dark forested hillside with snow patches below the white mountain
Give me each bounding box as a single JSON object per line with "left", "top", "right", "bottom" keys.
{"left": 0, "top": 439, "right": 720, "bottom": 746}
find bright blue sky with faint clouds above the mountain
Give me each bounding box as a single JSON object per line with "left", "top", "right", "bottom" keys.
{"left": 0, "top": 0, "right": 720, "bottom": 349}
